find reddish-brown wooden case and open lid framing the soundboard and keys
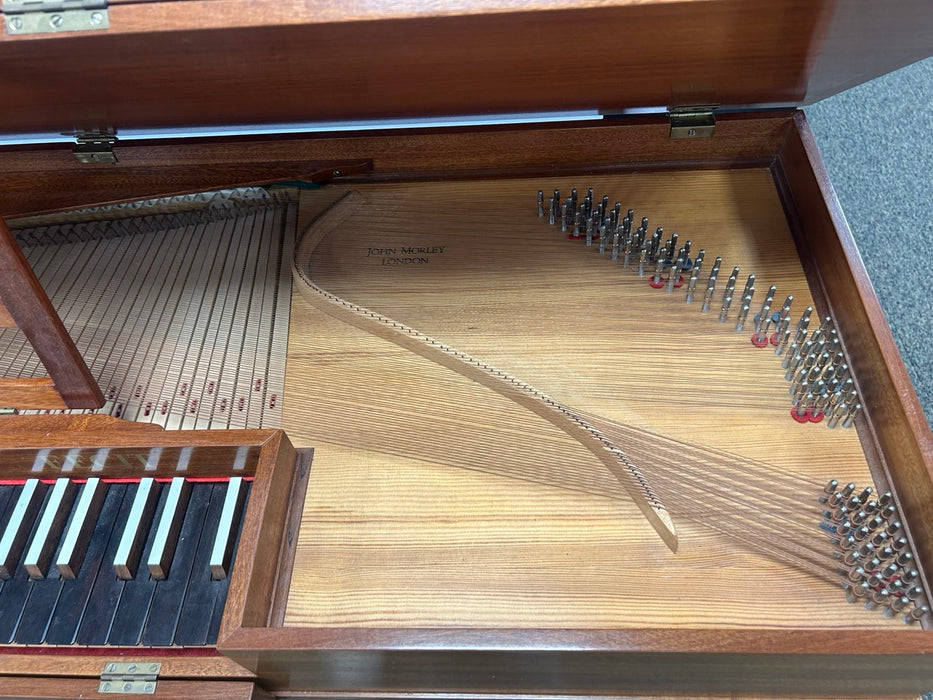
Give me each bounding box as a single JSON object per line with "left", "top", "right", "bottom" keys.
{"left": 0, "top": 0, "right": 933, "bottom": 698}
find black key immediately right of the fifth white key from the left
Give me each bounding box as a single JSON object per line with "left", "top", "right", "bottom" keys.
{"left": 143, "top": 483, "right": 213, "bottom": 646}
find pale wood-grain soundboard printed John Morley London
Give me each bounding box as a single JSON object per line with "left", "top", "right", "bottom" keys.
{"left": 284, "top": 169, "right": 904, "bottom": 630}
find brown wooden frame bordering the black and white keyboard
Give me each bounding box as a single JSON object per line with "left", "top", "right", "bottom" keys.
{"left": 0, "top": 415, "right": 294, "bottom": 698}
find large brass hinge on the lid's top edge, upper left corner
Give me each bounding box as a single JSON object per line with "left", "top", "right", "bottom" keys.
{"left": 0, "top": 0, "right": 110, "bottom": 35}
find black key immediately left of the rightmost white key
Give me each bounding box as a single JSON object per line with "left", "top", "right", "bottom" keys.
{"left": 175, "top": 479, "right": 240, "bottom": 646}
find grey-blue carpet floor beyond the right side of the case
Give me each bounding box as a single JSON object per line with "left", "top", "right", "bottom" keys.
{"left": 805, "top": 58, "right": 933, "bottom": 432}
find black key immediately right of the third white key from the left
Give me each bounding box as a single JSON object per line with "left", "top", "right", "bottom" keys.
{"left": 45, "top": 483, "right": 127, "bottom": 644}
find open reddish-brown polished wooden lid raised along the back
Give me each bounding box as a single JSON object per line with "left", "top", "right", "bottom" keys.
{"left": 0, "top": 0, "right": 933, "bottom": 135}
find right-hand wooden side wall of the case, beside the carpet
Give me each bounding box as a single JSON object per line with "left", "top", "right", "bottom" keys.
{"left": 780, "top": 114, "right": 933, "bottom": 608}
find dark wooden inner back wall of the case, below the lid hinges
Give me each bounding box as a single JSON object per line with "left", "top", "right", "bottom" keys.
{"left": 0, "top": 116, "right": 792, "bottom": 218}
